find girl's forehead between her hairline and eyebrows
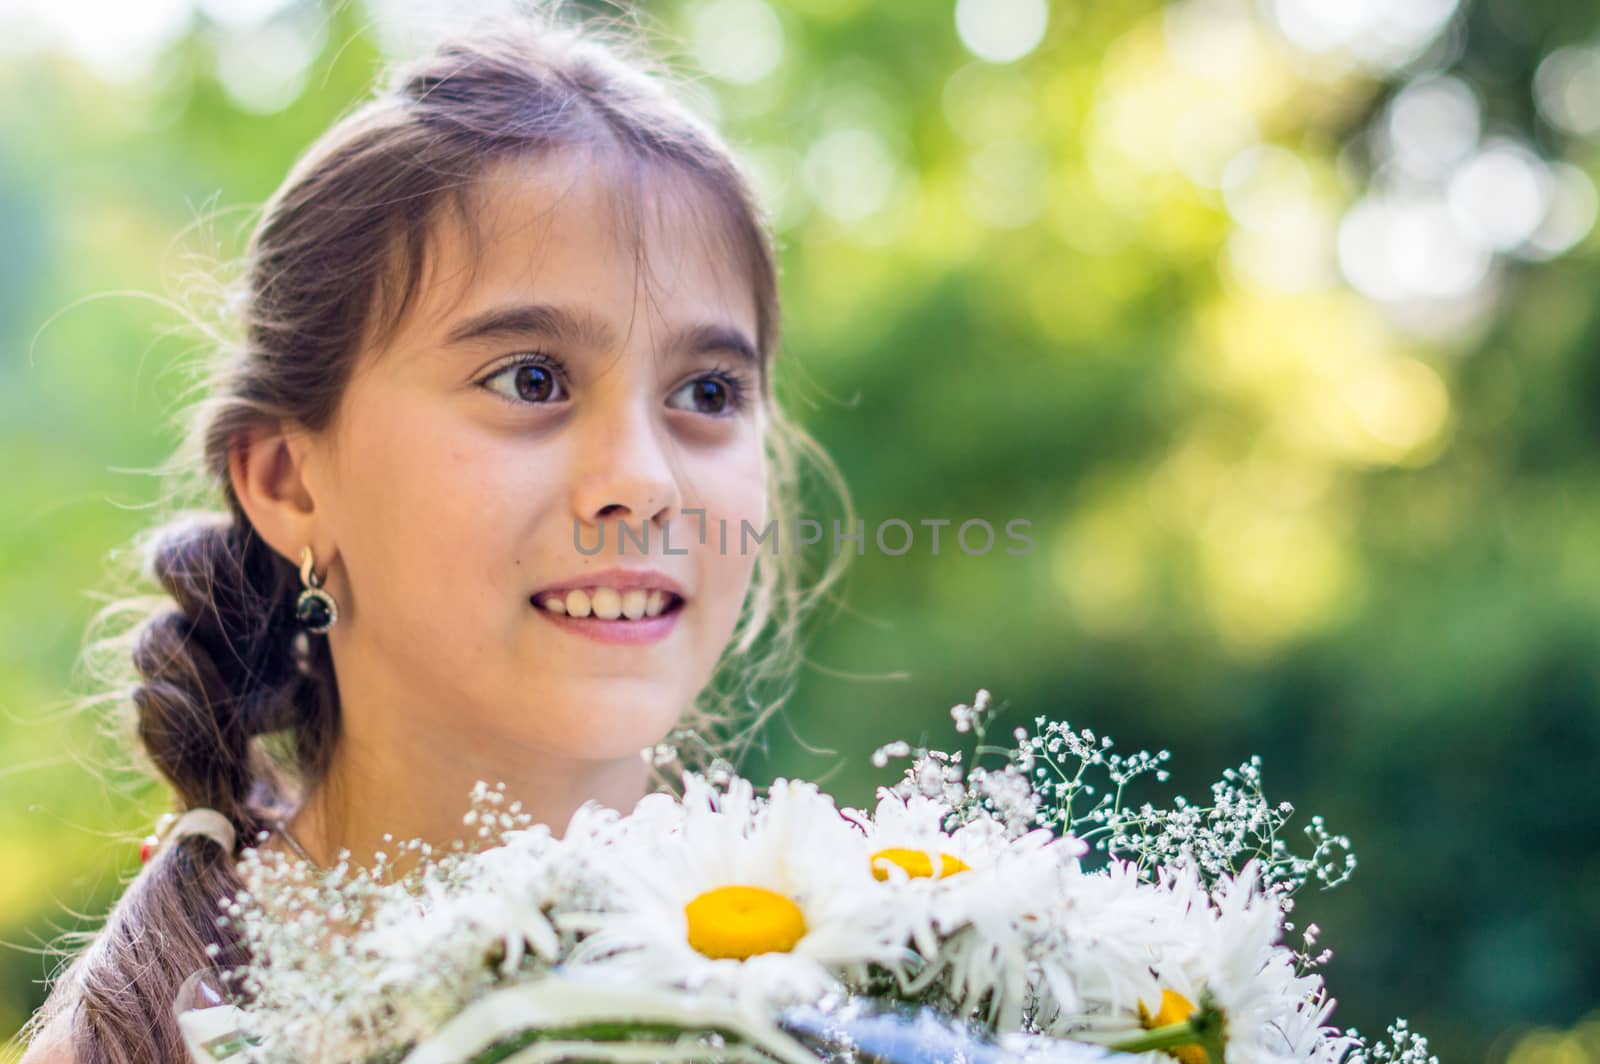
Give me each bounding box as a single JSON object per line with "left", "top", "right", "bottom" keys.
{"left": 398, "top": 149, "right": 757, "bottom": 352}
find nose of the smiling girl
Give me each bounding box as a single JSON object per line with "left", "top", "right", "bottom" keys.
{"left": 573, "top": 396, "right": 683, "bottom": 534}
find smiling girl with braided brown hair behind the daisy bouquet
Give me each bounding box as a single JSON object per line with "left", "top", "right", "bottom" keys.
{"left": 24, "top": 10, "right": 853, "bottom": 1064}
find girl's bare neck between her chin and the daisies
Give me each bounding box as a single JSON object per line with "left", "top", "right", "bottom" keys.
{"left": 290, "top": 713, "right": 650, "bottom": 878}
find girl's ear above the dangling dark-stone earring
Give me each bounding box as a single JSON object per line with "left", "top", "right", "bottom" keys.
{"left": 227, "top": 422, "right": 334, "bottom": 574}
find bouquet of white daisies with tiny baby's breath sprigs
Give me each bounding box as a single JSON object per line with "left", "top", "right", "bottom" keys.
{"left": 174, "top": 691, "right": 1437, "bottom": 1064}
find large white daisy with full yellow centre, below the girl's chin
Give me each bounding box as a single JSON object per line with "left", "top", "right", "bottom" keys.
{"left": 565, "top": 774, "right": 898, "bottom": 1013}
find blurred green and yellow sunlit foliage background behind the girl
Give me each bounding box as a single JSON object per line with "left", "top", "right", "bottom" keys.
{"left": 0, "top": 0, "right": 1600, "bottom": 1064}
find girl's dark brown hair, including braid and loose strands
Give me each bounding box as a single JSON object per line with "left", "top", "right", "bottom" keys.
{"left": 27, "top": 10, "right": 854, "bottom": 1064}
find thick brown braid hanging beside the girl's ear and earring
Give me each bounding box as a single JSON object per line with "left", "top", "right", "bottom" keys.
{"left": 37, "top": 514, "right": 338, "bottom": 1064}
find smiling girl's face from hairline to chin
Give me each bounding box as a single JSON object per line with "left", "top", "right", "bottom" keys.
{"left": 306, "top": 155, "right": 766, "bottom": 760}
